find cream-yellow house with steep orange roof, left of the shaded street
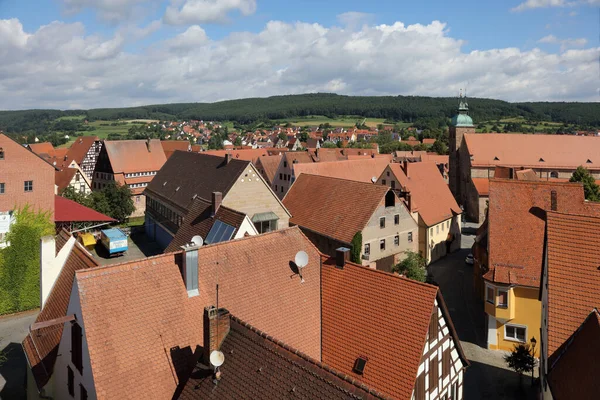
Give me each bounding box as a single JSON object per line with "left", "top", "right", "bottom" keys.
{"left": 377, "top": 161, "right": 461, "bottom": 264}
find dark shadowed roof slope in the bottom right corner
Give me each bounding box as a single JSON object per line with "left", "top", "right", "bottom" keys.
{"left": 548, "top": 309, "right": 600, "bottom": 400}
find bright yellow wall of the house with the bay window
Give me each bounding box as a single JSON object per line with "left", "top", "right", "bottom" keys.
{"left": 485, "top": 286, "right": 542, "bottom": 357}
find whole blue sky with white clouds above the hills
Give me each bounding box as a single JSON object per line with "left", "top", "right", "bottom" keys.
{"left": 0, "top": 0, "right": 600, "bottom": 110}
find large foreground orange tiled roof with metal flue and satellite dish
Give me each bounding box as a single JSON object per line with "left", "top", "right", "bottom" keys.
{"left": 76, "top": 228, "right": 321, "bottom": 399}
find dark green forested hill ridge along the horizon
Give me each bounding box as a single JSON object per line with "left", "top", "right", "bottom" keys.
{"left": 0, "top": 94, "right": 600, "bottom": 132}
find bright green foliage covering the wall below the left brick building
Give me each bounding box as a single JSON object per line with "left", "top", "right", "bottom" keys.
{"left": 0, "top": 206, "right": 54, "bottom": 314}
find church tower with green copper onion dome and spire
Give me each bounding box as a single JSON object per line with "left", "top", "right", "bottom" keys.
{"left": 449, "top": 92, "right": 475, "bottom": 204}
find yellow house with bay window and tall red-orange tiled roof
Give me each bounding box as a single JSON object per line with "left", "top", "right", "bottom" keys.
{"left": 473, "top": 179, "right": 596, "bottom": 356}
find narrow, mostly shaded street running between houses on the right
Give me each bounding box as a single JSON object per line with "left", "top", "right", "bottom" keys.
{"left": 429, "top": 224, "right": 535, "bottom": 400}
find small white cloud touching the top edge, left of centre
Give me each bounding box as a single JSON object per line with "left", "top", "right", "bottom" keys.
{"left": 164, "top": 0, "right": 256, "bottom": 25}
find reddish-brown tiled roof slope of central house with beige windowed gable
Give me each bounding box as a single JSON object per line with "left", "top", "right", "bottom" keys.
{"left": 283, "top": 174, "right": 389, "bottom": 243}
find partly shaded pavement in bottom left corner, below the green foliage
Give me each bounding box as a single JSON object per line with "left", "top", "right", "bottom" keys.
{"left": 0, "top": 310, "right": 38, "bottom": 399}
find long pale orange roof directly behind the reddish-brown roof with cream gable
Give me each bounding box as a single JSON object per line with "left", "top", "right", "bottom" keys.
{"left": 294, "top": 156, "right": 390, "bottom": 183}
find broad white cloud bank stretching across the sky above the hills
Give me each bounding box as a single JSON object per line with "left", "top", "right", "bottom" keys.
{"left": 0, "top": 20, "right": 600, "bottom": 109}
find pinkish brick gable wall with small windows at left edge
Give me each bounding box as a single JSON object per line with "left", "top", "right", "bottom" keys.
{"left": 0, "top": 134, "right": 54, "bottom": 221}
